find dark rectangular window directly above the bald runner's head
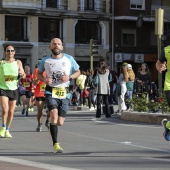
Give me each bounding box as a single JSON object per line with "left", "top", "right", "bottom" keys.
{"left": 39, "top": 18, "right": 63, "bottom": 42}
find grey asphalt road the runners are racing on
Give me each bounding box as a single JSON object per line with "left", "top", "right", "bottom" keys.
{"left": 0, "top": 107, "right": 170, "bottom": 170}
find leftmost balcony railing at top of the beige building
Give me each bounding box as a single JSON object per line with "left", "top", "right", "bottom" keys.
{"left": 2, "top": 0, "right": 41, "bottom": 9}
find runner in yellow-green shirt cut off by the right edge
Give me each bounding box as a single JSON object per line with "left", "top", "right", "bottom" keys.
{"left": 156, "top": 46, "right": 170, "bottom": 141}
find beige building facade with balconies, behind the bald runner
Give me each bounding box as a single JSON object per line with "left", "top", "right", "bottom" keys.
{"left": 0, "top": 0, "right": 110, "bottom": 71}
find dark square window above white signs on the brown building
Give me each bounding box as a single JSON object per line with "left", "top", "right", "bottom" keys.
{"left": 122, "top": 30, "right": 136, "bottom": 46}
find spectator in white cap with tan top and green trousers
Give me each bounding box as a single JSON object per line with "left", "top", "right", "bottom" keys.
{"left": 126, "top": 64, "right": 135, "bottom": 111}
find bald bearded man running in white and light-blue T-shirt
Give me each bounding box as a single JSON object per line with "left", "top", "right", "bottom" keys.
{"left": 37, "top": 38, "right": 80, "bottom": 153}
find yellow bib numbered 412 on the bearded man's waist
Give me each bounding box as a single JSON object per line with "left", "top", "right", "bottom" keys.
{"left": 52, "top": 87, "right": 66, "bottom": 99}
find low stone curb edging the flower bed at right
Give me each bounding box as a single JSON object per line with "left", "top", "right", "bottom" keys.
{"left": 121, "top": 112, "right": 170, "bottom": 124}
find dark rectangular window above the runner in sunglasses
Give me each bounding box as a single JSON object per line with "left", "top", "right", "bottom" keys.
{"left": 5, "top": 16, "right": 28, "bottom": 41}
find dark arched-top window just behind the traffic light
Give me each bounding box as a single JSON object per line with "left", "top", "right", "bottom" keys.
{"left": 75, "top": 20, "right": 101, "bottom": 44}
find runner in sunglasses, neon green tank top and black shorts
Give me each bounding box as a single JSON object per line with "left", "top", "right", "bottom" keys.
{"left": 0, "top": 45, "right": 25, "bottom": 138}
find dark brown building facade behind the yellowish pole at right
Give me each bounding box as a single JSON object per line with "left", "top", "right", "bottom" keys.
{"left": 113, "top": 0, "right": 170, "bottom": 81}
